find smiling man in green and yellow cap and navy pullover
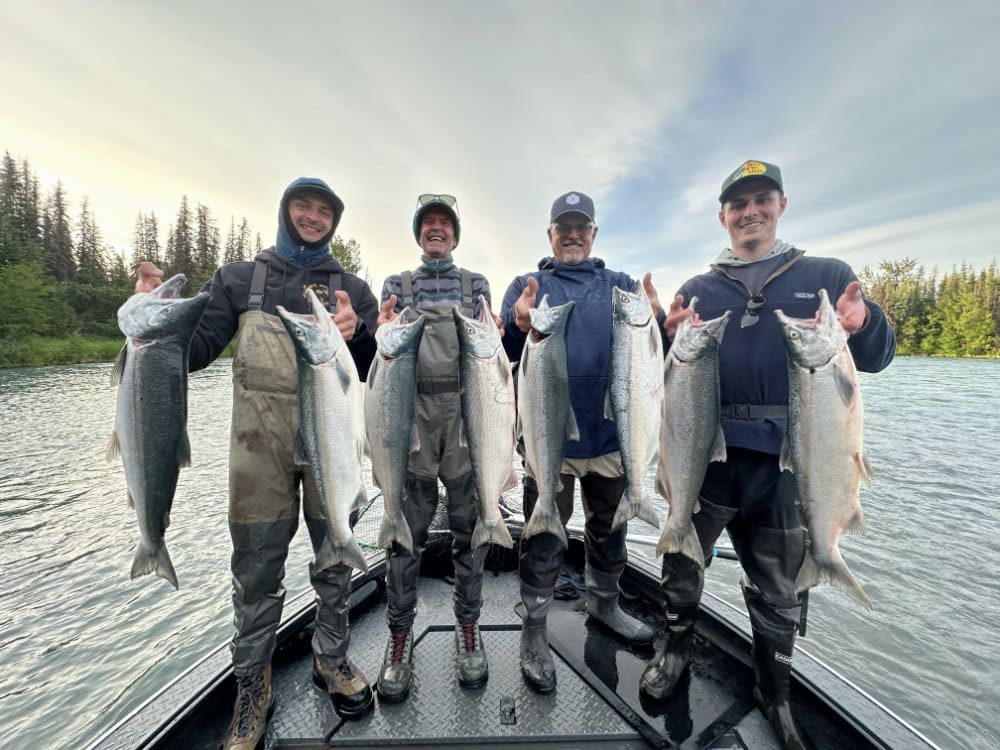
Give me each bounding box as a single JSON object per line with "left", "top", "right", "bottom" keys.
{"left": 639, "top": 161, "right": 896, "bottom": 749}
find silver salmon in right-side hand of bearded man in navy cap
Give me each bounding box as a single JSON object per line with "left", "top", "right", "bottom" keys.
{"left": 604, "top": 284, "right": 663, "bottom": 529}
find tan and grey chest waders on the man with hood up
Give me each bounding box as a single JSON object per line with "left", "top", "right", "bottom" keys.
{"left": 229, "top": 261, "right": 351, "bottom": 676}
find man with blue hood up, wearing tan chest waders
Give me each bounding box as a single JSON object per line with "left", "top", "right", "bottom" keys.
{"left": 136, "top": 177, "right": 378, "bottom": 750}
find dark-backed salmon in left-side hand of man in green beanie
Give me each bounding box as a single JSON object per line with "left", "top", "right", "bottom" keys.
{"left": 365, "top": 307, "right": 427, "bottom": 554}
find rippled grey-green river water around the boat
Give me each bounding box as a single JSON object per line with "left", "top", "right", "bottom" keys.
{"left": 0, "top": 358, "right": 1000, "bottom": 750}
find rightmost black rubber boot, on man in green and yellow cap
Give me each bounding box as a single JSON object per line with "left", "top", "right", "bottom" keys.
{"left": 753, "top": 630, "right": 813, "bottom": 750}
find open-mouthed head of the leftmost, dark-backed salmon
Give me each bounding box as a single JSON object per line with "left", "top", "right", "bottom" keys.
{"left": 118, "top": 273, "right": 208, "bottom": 341}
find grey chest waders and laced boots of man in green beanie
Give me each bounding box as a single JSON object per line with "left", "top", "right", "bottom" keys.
{"left": 378, "top": 268, "right": 487, "bottom": 701}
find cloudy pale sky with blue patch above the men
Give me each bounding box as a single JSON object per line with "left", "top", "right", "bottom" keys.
{"left": 0, "top": 0, "right": 1000, "bottom": 296}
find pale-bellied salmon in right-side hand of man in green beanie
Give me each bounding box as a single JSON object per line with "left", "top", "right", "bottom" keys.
{"left": 452, "top": 295, "right": 517, "bottom": 548}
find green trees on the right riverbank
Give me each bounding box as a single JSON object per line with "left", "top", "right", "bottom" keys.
{"left": 859, "top": 258, "right": 1000, "bottom": 357}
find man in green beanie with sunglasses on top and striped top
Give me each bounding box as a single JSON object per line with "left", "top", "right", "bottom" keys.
{"left": 377, "top": 193, "right": 498, "bottom": 702}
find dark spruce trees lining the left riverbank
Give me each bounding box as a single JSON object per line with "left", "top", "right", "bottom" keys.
{"left": 0, "top": 151, "right": 361, "bottom": 366}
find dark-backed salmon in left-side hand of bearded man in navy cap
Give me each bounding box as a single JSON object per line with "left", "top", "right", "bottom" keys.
{"left": 517, "top": 295, "right": 580, "bottom": 547}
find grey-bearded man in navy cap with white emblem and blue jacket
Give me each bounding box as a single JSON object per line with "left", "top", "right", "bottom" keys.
{"left": 500, "top": 192, "right": 660, "bottom": 693}
